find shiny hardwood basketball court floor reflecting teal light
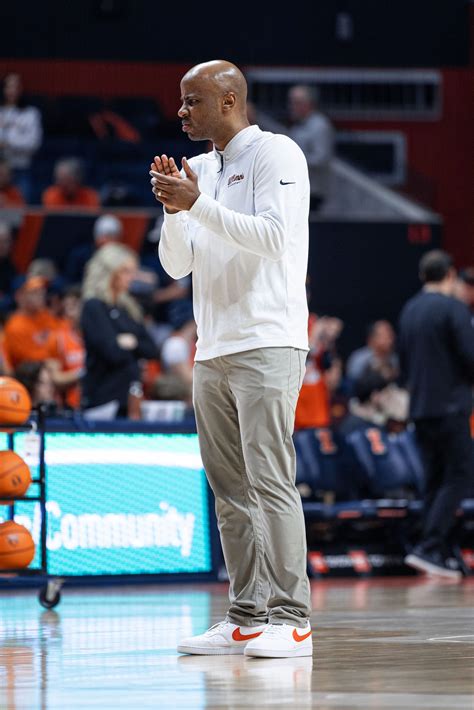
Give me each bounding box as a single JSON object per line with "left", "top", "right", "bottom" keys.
{"left": 0, "top": 577, "right": 474, "bottom": 710}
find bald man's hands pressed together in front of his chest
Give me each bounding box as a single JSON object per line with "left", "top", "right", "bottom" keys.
{"left": 150, "top": 155, "right": 201, "bottom": 213}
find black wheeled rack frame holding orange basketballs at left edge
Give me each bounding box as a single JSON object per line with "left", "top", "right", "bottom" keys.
{"left": 0, "top": 407, "right": 64, "bottom": 609}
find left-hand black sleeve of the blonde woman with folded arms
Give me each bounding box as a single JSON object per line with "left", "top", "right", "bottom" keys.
{"left": 81, "top": 298, "right": 135, "bottom": 365}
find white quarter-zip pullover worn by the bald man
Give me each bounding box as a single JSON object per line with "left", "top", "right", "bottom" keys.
{"left": 159, "top": 126, "right": 309, "bottom": 360}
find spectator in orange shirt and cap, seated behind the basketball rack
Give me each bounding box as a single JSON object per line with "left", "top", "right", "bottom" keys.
{"left": 5, "top": 276, "right": 60, "bottom": 368}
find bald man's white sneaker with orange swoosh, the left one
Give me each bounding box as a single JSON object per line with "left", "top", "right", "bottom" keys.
{"left": 178, "top": 621, "right": 266, "bottom": 656}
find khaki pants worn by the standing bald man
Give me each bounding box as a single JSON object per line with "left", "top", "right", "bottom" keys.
{"left": 194, "top": 347, "right": 311, "bottom": 626}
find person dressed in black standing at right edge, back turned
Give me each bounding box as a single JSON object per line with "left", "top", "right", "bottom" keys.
{"left": 399, "top": 250, "right": 474, "bottom": 578}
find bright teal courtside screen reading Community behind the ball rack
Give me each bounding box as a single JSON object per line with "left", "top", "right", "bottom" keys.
{"left": 0, "top": 433, "right": 211, "bottom": 576}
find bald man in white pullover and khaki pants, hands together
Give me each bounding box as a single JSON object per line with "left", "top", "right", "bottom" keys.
{"left": 150, "top": 61, "right": 312, "bottom": 657}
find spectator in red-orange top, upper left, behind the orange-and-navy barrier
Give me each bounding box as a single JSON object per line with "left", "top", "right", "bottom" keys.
{"left": 42, "top": 158, "right": 100, "bottom": 209}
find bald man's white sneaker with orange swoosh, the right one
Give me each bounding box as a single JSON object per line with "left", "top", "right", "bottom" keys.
{"left": 244, "top": 623, "right": 313, "bottom": 658}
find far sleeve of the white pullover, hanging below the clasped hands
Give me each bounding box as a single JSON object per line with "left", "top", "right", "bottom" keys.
{"left": 158, "top": 211, "right": 194, "bottom": 279}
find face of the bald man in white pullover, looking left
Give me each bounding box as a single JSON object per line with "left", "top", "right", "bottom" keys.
{"left": 178, "top": 78, "right": 222, "bottom": 141}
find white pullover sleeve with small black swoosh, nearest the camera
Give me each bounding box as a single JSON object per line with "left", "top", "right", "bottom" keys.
{"left": 189, "top": 135, "right": 309, "bottom": 261}
